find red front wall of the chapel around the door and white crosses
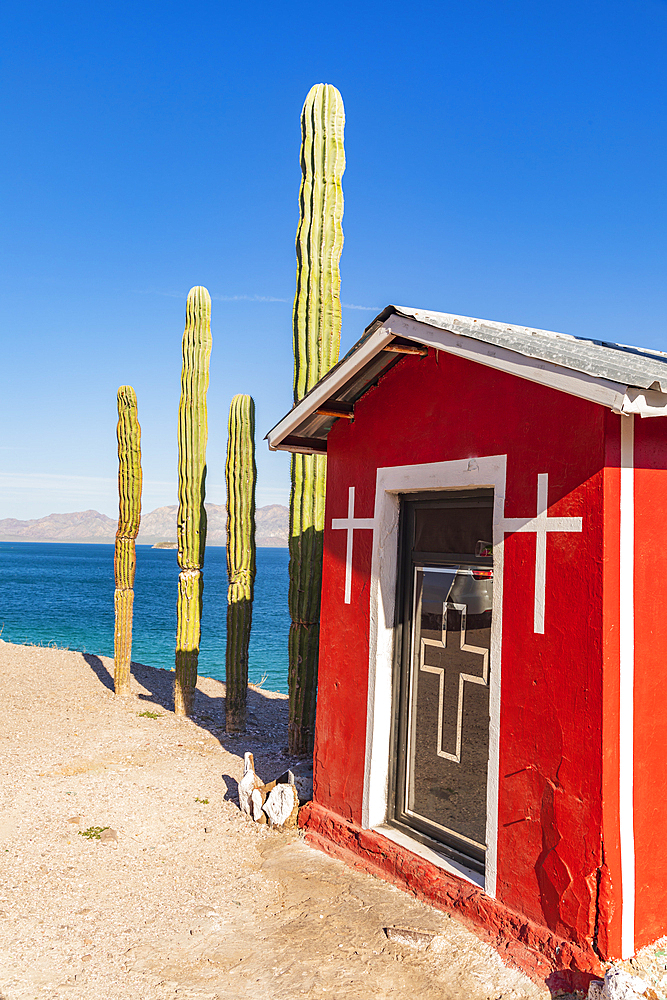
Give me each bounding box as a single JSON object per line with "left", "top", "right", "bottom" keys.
{"left": 315, "top": 351, "right": 607, "bottom": 948}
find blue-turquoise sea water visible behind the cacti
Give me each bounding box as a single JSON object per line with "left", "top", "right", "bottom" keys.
{"left": 0, "top": 542, "right": 289, "bottom": 693}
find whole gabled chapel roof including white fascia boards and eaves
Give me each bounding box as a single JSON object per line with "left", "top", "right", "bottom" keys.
{"left": 267, "top": 306, "right": 667, "bottom": 452}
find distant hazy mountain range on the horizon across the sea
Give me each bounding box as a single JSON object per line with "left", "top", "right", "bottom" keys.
{"left": 0, "top": 503, "right": 289, "bottom": 548}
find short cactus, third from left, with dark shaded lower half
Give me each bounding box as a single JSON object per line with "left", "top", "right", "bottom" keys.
{"left": 225, "top": 396, "right": 257, "bottom": 733}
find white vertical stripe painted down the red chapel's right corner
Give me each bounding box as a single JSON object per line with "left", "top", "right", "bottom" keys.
{"left": 618, "top": 416, "right": 635, "bottom": 958}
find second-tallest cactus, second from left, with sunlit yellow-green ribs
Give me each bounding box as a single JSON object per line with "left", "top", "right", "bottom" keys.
{"left": 174, "top": 287, "right": 211, "bottom": 715}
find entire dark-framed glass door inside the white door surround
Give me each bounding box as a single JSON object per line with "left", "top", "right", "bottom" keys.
{"left": 393, "top": 490, "right": 493, "bottom": 871}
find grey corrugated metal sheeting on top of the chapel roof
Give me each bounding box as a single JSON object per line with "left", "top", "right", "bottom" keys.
{"left": 384, "top": 306, "right": 667, "bottom": 392}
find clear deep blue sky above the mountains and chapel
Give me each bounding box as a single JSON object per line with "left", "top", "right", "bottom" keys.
{"left": 0, "top": 0, "right": 667, "bottom": 518}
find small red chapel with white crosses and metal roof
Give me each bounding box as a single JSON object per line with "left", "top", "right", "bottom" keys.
{"left": 268, "top": 306, "right": 667, "bottom": 986}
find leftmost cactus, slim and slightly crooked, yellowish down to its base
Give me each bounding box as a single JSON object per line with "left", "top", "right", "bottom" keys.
{"left": 114, "top": 385, "right": 141, "bottom": 695}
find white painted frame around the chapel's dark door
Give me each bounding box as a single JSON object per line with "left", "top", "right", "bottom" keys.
{"left": 362, "top": 455, "right": 507, "bottom": 896}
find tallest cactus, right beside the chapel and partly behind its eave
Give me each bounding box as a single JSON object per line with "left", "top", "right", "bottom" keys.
{"left": 289, "top": 83, "right": 345, "bottom": 754}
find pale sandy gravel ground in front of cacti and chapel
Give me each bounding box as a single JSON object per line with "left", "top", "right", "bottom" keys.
{"left": 0, "top": 642, "right": 548, "bottom": 1000}
